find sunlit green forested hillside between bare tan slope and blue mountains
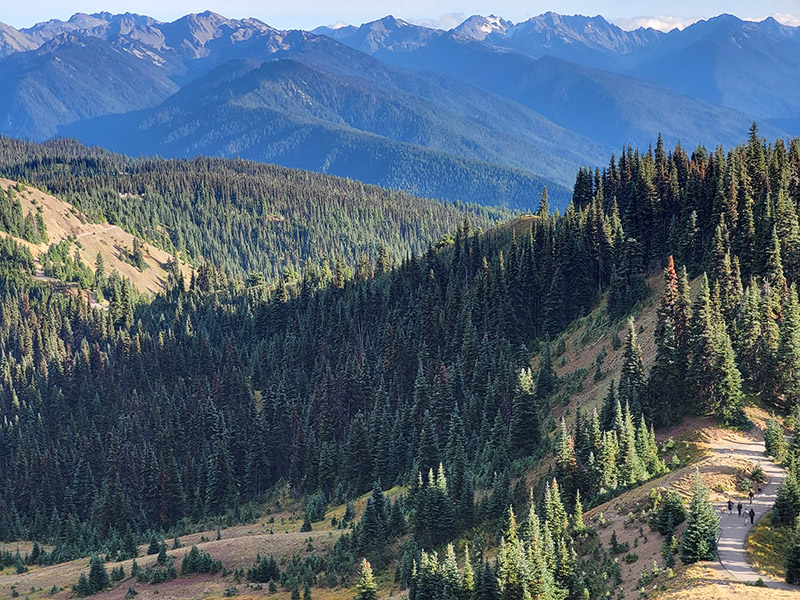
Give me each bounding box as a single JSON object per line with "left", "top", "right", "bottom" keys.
{"left": 0, "top": 138, "right": 510, "bottom": 278}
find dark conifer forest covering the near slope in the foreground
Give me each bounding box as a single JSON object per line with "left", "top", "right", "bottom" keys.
{"left": 0, "top": 126, "right": 800, "bottom": 600}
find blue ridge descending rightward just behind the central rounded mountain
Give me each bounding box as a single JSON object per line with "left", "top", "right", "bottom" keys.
{"left": 328, "top": 19, "right": 783, "bottom": 148}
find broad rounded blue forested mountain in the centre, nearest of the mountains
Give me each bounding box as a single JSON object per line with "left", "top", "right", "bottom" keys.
{"left": 61, "top": 48, "right": 602, "bottom": 210}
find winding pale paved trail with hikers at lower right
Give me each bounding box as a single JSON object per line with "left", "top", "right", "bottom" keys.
{"left": 711, "top": 437, "right": 800, "bottom": 592}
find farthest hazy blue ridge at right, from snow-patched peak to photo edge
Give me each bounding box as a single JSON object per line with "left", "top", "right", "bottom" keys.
{"left": 446, "top": 13, "right": 800, "bottom": 134}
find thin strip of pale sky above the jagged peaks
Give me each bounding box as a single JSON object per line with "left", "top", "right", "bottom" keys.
{"left": 0, "top": 0, "right": 800, "bottom": 29}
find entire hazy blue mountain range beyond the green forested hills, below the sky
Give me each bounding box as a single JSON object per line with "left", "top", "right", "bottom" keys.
{"left": 0, "top": 12, "right": 800, "bottom": 209}
